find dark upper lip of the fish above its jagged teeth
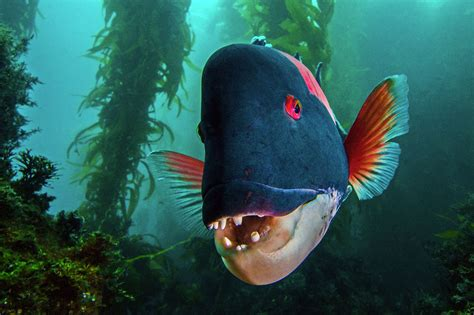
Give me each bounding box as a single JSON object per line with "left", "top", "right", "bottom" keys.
{"left": 202, "top": 179, "right": 318, "bottom": 226}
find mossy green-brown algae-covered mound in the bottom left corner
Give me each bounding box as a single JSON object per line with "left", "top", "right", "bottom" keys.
{"left": 0, "top": 195, "right": 131, "bottom": 314}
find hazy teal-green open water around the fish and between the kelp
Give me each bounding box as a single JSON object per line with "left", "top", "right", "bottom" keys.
{"left": 0, "top": 0, "right": 474, "bottom": 314}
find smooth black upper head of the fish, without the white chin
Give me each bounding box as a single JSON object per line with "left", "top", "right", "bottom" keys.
{"left": 199, "top": 44, "right": 348, "bottom": 225}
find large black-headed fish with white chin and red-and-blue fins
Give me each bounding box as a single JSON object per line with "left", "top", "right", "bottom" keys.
{"left": 147, "top": 38, "right": 409, "bottom": 285}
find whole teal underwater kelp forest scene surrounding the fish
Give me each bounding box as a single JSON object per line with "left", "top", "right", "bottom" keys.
{"left": 0, "top": 0, "right": 474, "bottom": 314}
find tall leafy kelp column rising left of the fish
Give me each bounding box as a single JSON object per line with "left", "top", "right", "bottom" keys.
{"left": 68, "top": 0, "right": 194, "bottom": 236}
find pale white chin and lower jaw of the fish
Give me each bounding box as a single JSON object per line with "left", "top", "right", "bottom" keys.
{"left": 214, "top": 192, "right": 340, "bottom": 285}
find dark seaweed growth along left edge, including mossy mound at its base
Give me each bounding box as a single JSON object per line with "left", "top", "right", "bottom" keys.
{"left": 0, "top": 25, "right": 128, "bottom": 314}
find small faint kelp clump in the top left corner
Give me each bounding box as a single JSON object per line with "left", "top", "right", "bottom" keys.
{"left": 0, "top": 0, "right": 40, "bottom": 38}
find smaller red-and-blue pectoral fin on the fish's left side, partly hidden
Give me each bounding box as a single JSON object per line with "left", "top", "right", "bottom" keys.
{"left": 147, "top": 151, "right": 208, "bottom": 237}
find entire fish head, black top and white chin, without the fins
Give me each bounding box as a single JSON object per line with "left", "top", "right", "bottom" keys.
{"left": 198, "top": 44, "right": 348, "bottom": 284}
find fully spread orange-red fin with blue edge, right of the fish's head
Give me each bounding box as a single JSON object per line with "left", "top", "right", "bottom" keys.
{"left": 344, "top": 75, "right": 408, "bottom": 200}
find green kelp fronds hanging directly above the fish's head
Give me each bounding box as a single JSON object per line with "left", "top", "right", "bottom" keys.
{"left": 235, "top": 0, "right": 334, "bottom": 80}
